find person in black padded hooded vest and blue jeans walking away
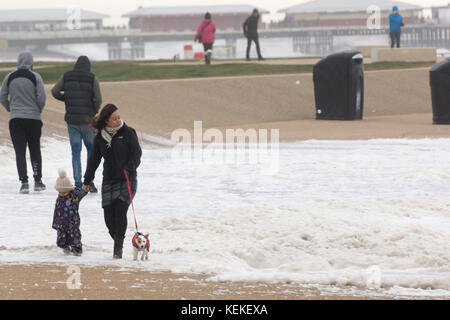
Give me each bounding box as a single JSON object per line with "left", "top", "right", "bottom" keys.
{"left": 52, "top": 56, "right": 102, "bottom": 192}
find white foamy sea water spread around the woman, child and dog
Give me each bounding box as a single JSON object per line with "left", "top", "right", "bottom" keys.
{"left": 0, "top": 136, "right": 450, "bottom": 298}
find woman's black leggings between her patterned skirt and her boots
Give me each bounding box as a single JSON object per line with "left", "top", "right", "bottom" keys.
{"left": 103, "top": 199, "right": 130, "bottom": 239}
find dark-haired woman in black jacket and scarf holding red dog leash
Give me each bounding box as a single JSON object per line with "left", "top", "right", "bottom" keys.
{"left": 82, "top": 104, "right": 142, "bottom": 259}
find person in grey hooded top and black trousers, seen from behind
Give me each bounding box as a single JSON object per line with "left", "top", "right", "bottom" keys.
{"left": 0, "top": 52, "right": 46, "bottom": 193}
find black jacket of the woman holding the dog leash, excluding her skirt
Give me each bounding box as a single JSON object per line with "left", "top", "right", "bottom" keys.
{"left": 84, "top": 123, "right": 142, "bottom": 185}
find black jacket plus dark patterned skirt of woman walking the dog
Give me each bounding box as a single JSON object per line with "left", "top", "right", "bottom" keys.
{"left": 84, "top": 123, "right": 142, "bottom": 207}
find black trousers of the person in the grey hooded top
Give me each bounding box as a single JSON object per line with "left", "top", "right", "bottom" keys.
{"left": 9, "top": 118, "right": 42, "bottom": 183}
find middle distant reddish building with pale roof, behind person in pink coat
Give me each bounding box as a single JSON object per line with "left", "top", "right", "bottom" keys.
{"left": 122, "top": 5, "right": 269, "bottom": 32}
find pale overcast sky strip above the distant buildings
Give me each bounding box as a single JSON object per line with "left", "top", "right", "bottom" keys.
{"left": 0, "top": 0, "right": 450, "bottom": 24}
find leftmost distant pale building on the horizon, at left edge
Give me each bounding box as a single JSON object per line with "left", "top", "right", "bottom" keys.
{"left": 0, "top": 9, "right": 108, "bottom": 32}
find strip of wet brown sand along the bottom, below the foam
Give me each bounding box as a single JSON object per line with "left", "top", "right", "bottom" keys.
{"left": 0, "top": 265, "right": 378, "bottom": 300}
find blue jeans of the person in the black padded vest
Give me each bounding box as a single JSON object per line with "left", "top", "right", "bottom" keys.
{"left": 67, "top": 124, "right": 94, "bottom": 189}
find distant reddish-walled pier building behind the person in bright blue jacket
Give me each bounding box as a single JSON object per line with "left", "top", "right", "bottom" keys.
{"left": 278, "top": 0, "right": 423, "bottom": 27}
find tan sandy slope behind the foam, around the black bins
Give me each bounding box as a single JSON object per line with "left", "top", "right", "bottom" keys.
{"left": 0, "top": 69, "right": 450, "bottom": 141}
